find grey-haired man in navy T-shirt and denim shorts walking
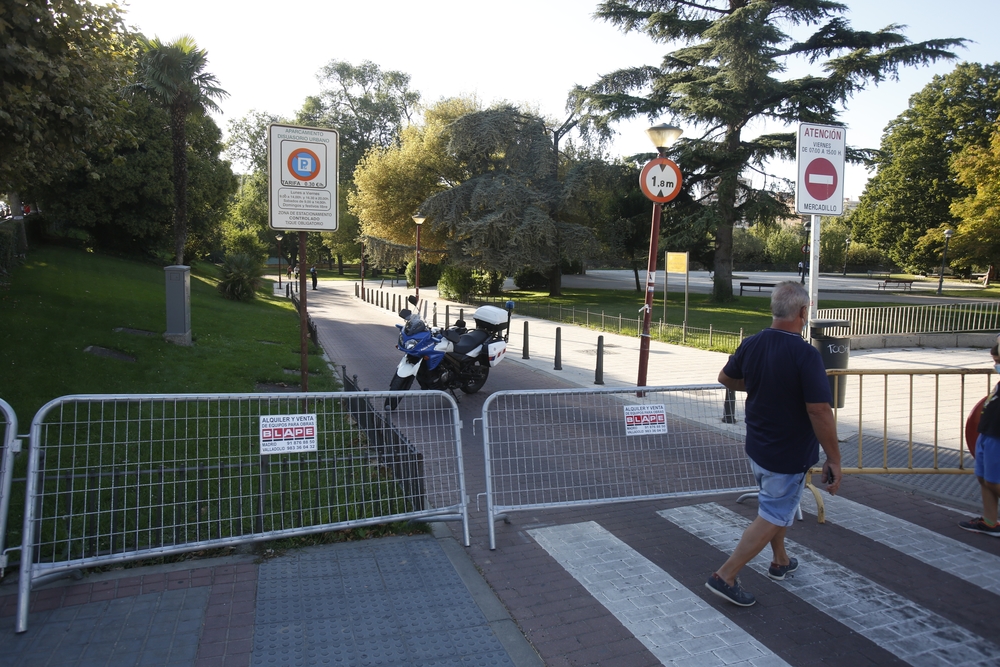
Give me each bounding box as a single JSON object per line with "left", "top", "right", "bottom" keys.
{"left": 705, "top": 282, "right": 840, "bottom": 607}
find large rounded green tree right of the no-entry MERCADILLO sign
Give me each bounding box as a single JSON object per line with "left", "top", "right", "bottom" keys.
{"left": 851, "top": 63, "right": 1000, "bottom": 271}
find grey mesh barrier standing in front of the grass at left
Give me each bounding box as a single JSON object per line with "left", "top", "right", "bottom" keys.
{"left": 16, "top": 391, "right": 469, "bottom": 632}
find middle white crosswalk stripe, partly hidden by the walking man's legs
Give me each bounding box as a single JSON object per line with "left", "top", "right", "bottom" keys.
{"left": 659, "top": 503, "right": 1000, "bottom": 667}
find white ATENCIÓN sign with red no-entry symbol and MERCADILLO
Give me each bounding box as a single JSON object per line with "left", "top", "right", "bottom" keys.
{"left": 795, "top": 123, "right": 847, "bottom": 215}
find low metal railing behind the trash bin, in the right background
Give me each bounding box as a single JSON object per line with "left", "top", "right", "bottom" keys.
{"left": 818, "top": 301, "right": 1000, "bottom": 336}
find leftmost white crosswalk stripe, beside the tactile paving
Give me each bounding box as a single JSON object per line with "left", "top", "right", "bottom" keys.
{"left": 528, "top": 521, "right": 787, "bottom": 667}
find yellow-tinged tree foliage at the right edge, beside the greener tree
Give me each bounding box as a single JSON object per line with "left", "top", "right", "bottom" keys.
{"left": 950, "top": 123, "right": 1000, "bottom": 270}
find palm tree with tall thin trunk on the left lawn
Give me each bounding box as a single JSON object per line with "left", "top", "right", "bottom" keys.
{"left": 129, "top": 35, "right": 229, "bottom": 264}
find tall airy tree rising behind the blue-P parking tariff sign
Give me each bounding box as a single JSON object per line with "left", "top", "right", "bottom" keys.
{"left": 297, "top": 60, "right": 420, "bottom": 272}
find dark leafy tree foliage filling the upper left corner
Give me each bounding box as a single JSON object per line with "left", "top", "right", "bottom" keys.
{"left": 0, "top": 0, "right": 131, "bottom": 191}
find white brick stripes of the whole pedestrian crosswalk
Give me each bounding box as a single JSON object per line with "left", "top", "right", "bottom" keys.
{"left": 528, "top": 494, "right": 1000, "bottom": 667}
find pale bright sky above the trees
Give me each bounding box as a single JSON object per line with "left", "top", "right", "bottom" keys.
{"left": 123, "top": 0, "right": 1000, "bottom": 198}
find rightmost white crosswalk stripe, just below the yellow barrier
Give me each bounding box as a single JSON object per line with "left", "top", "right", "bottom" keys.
{"left": 802, "top": 493, "right": 1000, "bottom": 595}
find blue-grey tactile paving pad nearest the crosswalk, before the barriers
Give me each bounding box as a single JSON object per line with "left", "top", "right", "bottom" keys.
{"left": 250, "top": 536, "right": 513, "bottom": 667}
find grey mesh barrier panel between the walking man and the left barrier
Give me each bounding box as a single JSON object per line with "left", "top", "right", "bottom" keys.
{"left": 483, "top": 385, "right": 756, "bottom": 549}
